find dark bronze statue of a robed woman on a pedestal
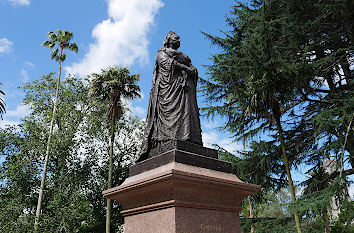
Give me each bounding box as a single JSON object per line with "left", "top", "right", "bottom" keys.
{"left": 138, "top": 31, "right": 202, "bottom": 161}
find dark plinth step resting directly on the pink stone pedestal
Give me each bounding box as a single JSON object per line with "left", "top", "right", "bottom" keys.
{"left": 129, "top": 147, "right": 232, "bottom": 176}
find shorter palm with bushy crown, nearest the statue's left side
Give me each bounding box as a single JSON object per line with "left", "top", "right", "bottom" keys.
{"left": 91, "top": 66, "right": 140, "bottom": 233}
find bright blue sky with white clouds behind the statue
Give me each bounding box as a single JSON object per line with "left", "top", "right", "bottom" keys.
{"left": 0, "top": 0, "right": 354, "bottom": 195}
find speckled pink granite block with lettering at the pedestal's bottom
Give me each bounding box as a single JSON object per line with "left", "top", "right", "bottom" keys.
{"left": 124, "top": 207, "right": 241, "bottom": 233}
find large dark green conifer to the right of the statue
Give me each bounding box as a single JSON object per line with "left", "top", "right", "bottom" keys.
{"left": 201, "top": 0, "right": 354, "bottom": 232}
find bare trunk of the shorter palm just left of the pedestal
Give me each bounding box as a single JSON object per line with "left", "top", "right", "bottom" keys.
{"left": 106, "top": 117, "right": 115, "bottom": 233}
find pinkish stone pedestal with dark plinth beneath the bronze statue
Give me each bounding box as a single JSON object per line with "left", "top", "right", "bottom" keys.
{"left": 103, "top": 141, "right": 260, "bottom": 233}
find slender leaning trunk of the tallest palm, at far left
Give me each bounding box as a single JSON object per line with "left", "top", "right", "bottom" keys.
{"left": 34, "top": 47, "right": 63, "bottom": 232}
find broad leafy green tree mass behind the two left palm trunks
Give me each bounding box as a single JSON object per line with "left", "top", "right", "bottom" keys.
{"left": 0, "top": 74, "right": 143, "bottom": 233}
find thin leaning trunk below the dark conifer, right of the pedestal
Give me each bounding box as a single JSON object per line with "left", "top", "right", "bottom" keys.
{"left": 274, "top": 115, "right": 301, "bottom": 233}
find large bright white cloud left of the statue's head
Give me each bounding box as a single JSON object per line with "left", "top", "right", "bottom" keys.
{"left": 66, "top": 0, "right": 163, "bottom": 75}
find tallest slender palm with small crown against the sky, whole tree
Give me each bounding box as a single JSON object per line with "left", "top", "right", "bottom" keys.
{"left": 34, "top": 29, "right": 79, "bottom": 231}
